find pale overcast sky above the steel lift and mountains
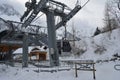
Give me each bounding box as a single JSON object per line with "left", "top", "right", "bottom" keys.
{"left": 0, "top": 0, "right": 107, "bottom": 36}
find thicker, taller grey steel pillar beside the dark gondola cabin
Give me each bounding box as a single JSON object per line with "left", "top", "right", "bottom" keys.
{"left": 46, "top": 11, "right": 59, "bottom": 66}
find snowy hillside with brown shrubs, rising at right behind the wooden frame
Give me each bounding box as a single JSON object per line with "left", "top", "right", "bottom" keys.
{"left": 80, "top": 29, "right": 120, "bottom": 60}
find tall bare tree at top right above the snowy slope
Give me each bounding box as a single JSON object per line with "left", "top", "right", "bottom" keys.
{"left": 105, "top": 0, "right": 120, "bottom": 28}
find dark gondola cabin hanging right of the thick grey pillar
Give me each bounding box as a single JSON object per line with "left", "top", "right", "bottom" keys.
{"left": 57, "top": 40, "right": 71, "bottom": 54}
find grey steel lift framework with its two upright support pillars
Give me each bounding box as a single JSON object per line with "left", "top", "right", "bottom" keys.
{"left": 0, "top": 0, "right": 89, "bottom": 67}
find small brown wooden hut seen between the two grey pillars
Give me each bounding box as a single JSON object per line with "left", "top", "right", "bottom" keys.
{"left": 29, "top": 48, "right": 47, "bottom": 61}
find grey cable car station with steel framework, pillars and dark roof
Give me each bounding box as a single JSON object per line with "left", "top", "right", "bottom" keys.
{"left": 0, "top": 0, "right": 89, "bottom": 67}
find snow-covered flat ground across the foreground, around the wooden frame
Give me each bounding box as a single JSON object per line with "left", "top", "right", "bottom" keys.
{"left": 0, "top": 61, "right": 120, "bottom": 80}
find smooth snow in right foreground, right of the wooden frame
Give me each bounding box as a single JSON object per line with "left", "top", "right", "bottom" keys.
{"left": 96, "top": 62, "right": 120, "bottom": 80}
